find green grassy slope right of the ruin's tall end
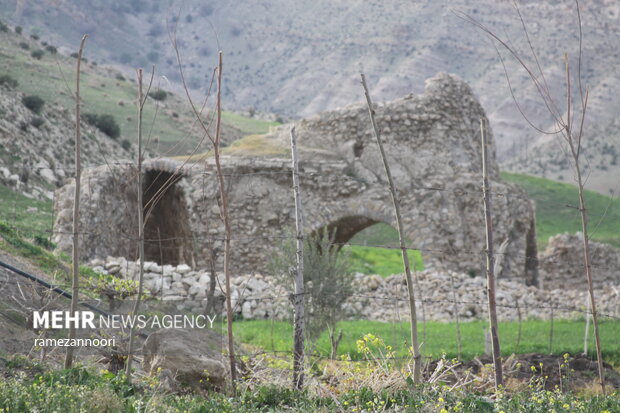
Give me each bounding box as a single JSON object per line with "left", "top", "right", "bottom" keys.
{"left": 501, "top": 172, "right": 620, "bottom": 247}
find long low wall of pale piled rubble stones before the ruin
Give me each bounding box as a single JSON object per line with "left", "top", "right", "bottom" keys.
{"left": 92, "top": 257, "right": 620, "bottom": 321}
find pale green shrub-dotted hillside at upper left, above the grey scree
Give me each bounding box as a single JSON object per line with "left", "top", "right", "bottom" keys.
{"left": 0, "top": 25, "right": 277, "bottom": 155}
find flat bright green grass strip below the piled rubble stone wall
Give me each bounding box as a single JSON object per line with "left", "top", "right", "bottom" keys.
{"left": 233, "top": 320, "right": 620, "bottom": 366}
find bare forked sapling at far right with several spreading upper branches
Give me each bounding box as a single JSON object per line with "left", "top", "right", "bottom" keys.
{"left": 457, "top": 0, "right": 605, "bottom": 394}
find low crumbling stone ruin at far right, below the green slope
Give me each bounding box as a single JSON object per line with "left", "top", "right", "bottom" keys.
{"left": 539, "top": 232, "right": 620, "bottom": 290}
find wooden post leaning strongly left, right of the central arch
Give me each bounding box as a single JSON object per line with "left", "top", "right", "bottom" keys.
{"left": 361, "top": 73, "right": 422, "bottom": 383}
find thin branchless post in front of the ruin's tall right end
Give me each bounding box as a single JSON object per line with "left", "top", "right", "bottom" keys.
{"left": 480, "top": 119, "right": 504, "bottom": 391}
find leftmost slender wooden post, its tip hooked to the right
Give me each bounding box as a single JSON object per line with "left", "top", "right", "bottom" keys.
{"left": 65, "top": 34, "right": 88, "bottom": 369}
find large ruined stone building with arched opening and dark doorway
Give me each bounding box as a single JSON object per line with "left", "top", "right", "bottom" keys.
{"left": 54, "top": 74, "right": 537, "bottom": 285}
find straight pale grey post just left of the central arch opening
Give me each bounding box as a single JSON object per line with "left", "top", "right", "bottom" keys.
{"left": 291, "top": 126, "right": 305, "bottom": 389}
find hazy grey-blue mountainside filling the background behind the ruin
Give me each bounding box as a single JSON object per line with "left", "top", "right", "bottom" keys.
{"left": 0, "top": 0, "right": 620, "bottom": 192}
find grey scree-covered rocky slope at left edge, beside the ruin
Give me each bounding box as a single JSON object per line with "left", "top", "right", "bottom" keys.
{"left": 0, "top": 84, "right": 131, "bottom": 199}
